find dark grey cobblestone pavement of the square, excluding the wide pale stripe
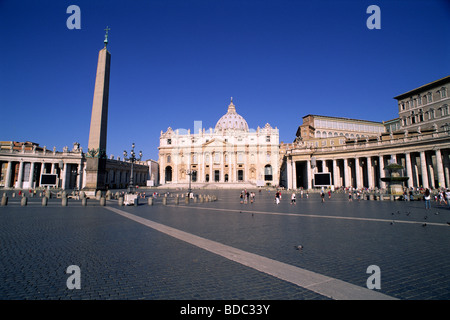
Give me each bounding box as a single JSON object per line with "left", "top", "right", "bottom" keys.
{"left": 0, "top": 190, "right": 450, "bottom": 300}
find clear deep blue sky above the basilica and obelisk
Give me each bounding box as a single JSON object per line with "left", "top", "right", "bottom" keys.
{"left": 0, "top": 0, "right": 450, "bottom": 159}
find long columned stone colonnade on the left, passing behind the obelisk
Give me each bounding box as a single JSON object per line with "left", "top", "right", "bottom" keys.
{"left": 0, "top": 141, "right": 148, "bottom": 190}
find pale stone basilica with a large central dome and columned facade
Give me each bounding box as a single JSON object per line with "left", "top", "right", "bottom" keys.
{"left": 158, "top": 99, "right": 280, "bottom": 187}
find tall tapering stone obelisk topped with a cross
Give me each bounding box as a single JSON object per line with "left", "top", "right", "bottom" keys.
{"left": 85, "top": 27, "right": 111, "bottom": 191}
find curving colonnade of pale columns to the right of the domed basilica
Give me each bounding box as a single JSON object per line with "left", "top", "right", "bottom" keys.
{"left": 286, "top": 147, "right": 450, "bottom": 189}
